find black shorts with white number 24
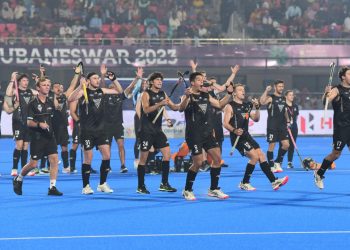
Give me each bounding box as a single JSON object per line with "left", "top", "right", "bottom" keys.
{"left": 139, "top": 130, "right": 169, "bottom": 152}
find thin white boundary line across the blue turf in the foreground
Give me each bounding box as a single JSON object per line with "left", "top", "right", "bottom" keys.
{"left": 0, "top": 231, "right": 350, "bottom": 241}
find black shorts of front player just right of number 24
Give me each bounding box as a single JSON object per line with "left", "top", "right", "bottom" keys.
{"left": 186, "top": 134, "right": 220, "bottom": 155}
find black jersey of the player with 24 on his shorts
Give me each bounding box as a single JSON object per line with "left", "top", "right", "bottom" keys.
{"left": 140, "top": 89, "right": 166, "bottom": 133}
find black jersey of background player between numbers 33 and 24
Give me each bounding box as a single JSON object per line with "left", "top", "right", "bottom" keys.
{"left": 103, "top": 93, "right": 127, "bottom": 124}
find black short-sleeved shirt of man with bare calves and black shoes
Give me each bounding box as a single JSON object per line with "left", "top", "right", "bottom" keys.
{"left": 27, "top": 97, "right": 55, "bottom": 137}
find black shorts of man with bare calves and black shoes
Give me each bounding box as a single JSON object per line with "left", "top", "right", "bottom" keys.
{"left": 30, "top": 136, "right": 57, "bottom": 161}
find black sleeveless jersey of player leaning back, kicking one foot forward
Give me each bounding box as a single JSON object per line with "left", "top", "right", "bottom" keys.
{"left": 229, "top": 101, "right": 253, "bottom": 133}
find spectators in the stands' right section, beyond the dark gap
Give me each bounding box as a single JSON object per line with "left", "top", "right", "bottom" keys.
{"left": 244, "top": 0, "right": 350, "bottom": 39}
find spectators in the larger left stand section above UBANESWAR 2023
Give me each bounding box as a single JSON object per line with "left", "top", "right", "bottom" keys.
{"left": 0, "top": 0, "right": 221, "bottom": 45}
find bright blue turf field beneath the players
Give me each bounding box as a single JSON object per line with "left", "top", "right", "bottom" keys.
{"left": 0, "top": 137, "right": 350, "bottom": 250}
